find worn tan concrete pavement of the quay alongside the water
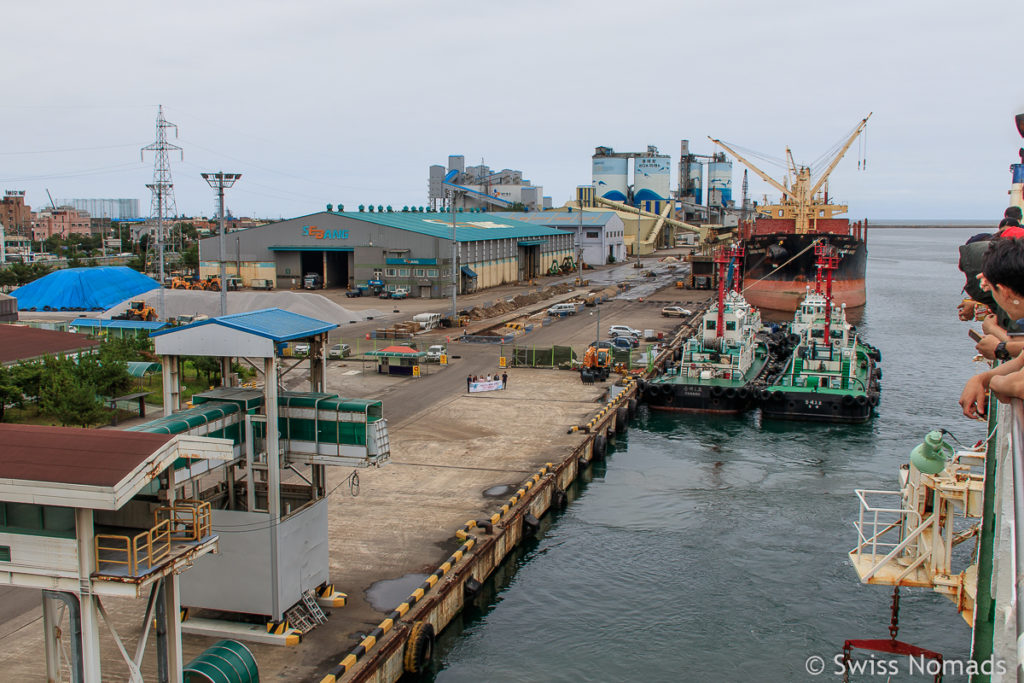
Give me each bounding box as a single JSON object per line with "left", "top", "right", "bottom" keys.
{"left": 0, "top": 260, "right": 709, "bottom": 681}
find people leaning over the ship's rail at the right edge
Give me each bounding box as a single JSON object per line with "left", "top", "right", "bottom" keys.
{"left": 958, "top": 207, "right": 1024, "bottom": 419}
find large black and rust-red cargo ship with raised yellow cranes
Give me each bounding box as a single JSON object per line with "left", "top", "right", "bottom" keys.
{"left": 711, "top": 114, "right": 870, "bottom": 311}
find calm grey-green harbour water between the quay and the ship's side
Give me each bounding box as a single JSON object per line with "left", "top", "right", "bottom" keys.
{"left": 433, "top": 229, "right": 984, "bottom": 683}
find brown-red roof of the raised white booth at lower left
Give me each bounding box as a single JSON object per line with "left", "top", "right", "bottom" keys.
{"left": 0, "top": 424, "right": 174, "bottom": 486}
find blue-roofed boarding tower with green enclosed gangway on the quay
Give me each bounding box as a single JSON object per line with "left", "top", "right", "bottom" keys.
{"left": 148, "top": 308, "right": 390, "bottom": 644}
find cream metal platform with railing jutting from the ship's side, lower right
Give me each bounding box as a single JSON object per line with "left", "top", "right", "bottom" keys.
{"left": 852, "top": 488, "right": 938, "bottom": 583}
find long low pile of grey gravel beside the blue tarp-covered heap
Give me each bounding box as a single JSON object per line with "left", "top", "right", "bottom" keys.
{"left": 101, "top": 290, "right": 383, "bottom": 325}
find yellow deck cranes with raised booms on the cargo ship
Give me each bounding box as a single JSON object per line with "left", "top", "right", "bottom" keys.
{"left": 708, "top": 114, "right": 871, "bottom": 234}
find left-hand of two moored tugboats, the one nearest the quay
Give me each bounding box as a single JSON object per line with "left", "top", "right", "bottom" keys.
{"left": 643, "top": 247, "right": 768, "bottom": 414}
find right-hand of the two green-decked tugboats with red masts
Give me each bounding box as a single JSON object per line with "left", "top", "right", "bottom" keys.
{"left": 758, "top": 245, "right": 882, "bottom": 424}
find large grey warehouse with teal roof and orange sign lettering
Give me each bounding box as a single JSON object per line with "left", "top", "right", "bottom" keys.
{"left": 200, "top": 211, "right": 575, "bottom": 298}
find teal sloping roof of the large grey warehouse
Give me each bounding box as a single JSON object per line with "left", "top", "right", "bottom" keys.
{"left": 332, "top": 211, "right": 565, "bottom": 242}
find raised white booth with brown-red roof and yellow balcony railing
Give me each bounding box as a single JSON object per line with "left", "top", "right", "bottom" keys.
{"left": 0, "top": 424, "right": 232, "bottom": 682}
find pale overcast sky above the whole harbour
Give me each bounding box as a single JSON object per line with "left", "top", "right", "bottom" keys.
{"left": 0, "top": 0, "right": 1024, "bottom": 220}
